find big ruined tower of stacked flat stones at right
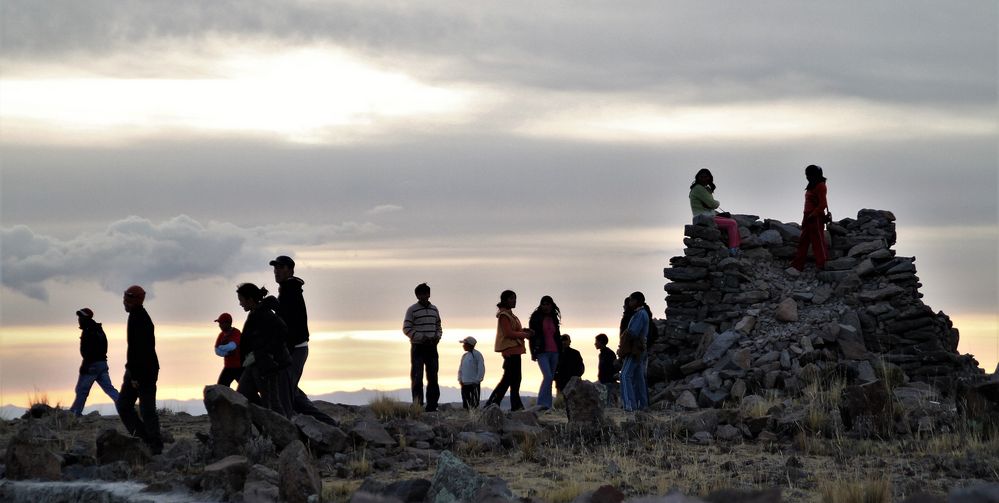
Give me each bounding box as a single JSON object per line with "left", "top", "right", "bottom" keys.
{"left": 648, "top": 209, "right": 984, "bottom": 408}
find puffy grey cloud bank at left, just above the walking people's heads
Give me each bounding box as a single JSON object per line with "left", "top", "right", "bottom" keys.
{"left": 0, "top": 215, "right": 386, "bottom": 301}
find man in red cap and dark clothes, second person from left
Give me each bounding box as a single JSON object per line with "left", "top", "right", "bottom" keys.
{"left": 116, "top": 285, "right": 163, "bottom": 454}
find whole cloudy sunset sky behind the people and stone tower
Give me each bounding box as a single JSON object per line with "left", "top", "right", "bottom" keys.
{"left": 0, "top": 0, "right": 999, "bottom": 403}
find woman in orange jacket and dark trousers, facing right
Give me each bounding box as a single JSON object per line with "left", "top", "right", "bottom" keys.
{"left": 486, "top": 290, "right": 531, "bottom": 410}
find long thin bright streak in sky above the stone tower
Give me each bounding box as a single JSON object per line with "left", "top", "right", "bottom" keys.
{"left": 520, "top": 99, "right": 999, "bottom": 142}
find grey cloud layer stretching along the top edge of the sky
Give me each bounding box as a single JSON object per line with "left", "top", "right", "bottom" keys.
{"left": 0, "top": 0, "right": 999, "bottom": 105}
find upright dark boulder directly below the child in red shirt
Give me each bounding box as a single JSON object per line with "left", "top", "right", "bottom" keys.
{"left": 204, "top": 384, "right": 253, "bottom": 458}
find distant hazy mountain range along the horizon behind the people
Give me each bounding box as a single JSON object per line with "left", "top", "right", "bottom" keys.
{"left": 0, "top": 386, "right": 537, "bottom": 420}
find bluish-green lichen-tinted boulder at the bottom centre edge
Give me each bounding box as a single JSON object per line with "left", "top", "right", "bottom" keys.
{"left": 427, "top": 451, "right": 517, "bottom": 503}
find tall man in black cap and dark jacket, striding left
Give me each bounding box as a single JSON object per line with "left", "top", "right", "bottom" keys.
{"left": 270, "top": 255, "right": 336, "bottom": 425}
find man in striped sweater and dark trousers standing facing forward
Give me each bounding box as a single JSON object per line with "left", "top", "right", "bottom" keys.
{"left": 402, "top": 283, "right": 443, "bottom": 412}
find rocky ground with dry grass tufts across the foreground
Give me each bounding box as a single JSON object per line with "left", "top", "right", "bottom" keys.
{"left": 0, "top": 382, "right": 999, "bottom": 503}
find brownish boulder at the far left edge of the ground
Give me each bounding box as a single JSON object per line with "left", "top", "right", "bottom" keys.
{"left": 4, "top": 420, "right": 63, "bottom": 480}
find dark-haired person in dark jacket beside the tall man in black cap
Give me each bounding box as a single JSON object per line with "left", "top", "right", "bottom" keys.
{"left": 236, "top": 283, "right": 294, "bottom": 418}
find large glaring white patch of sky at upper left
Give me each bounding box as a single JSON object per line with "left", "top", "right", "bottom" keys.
{"left": 0, "top": 44, "right": 471, "bottom": 143}
